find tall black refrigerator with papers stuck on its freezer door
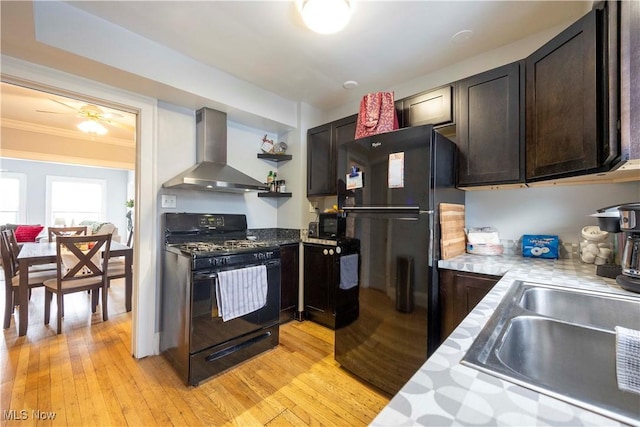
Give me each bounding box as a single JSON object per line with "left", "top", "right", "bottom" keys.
{"left": 335, "top": 125, "right": 464, "bottom": 394}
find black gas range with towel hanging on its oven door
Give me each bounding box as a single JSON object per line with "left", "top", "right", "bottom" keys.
{"left": 160, "top": 213, "right": 280, "bottom": 385}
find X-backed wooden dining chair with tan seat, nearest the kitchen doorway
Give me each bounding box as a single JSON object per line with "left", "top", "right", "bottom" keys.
{"left": 44, "top": 234, "right": 111, "bottom": 334}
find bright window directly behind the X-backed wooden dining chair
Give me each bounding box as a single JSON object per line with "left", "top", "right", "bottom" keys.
{"left": 47, "top": 176, "right": 107, "bottom": 226}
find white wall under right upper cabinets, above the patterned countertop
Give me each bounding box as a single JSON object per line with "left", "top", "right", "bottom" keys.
{"left": 465, "top": 182, "right": 640, "bottom": 243}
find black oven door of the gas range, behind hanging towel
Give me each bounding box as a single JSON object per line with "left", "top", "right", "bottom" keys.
{"left": 190, "top": 260, "right": 280, "bottom": 354}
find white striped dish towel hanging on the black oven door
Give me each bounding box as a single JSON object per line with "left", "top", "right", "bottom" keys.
{"left": 216, "top": 265, "right": 268, "bottom": 322}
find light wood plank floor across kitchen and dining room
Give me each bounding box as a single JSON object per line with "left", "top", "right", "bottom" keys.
{"left": 0, "top": 281, "right": 389, "bottom": 426}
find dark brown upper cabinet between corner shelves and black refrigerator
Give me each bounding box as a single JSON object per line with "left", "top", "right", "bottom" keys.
{"left": 307, "top": 114, "right": 358, "bottom": 196}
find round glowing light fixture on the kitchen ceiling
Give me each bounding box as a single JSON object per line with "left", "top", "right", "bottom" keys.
{"left": 300, "top": 0, "right": 351, "bottom": 34}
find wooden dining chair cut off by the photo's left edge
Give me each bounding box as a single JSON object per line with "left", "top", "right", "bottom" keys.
{"left": 0, "top": 233, "right": 56, "bottom": 329}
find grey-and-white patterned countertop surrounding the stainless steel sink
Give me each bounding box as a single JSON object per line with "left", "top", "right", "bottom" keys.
{"left": 371, "top": 254, "right": 640, "bottom": 426}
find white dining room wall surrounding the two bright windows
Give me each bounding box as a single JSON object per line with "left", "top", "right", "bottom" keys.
{"left": 0, "top": 158, "right": 129, "bottom": 237}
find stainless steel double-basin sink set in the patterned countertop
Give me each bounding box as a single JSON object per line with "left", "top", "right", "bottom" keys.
{"left": 462, "top": 282, "right": 640, "bottom": 424}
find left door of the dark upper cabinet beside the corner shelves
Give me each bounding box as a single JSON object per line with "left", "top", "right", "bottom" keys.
{"left": 307, "top": 123, "right": 335, "bottom": 196}
